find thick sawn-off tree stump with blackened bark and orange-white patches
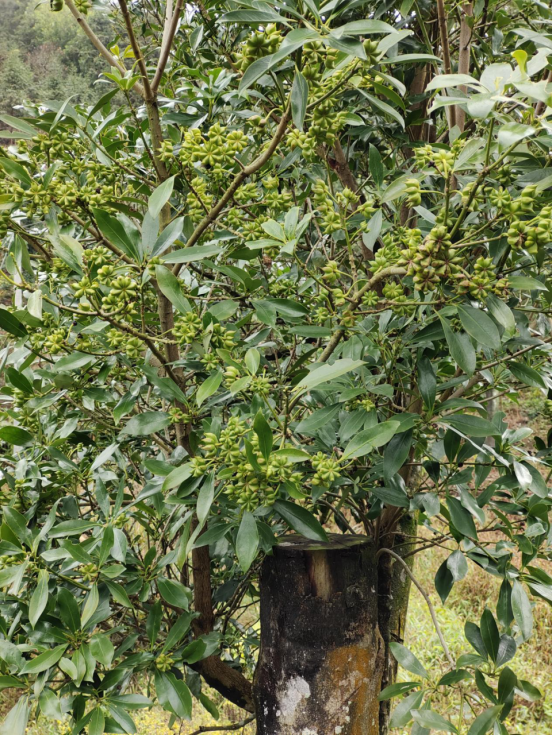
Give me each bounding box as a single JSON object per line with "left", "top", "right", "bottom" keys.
{"left": 255, "top": 534, "right": 385, "bottom": 734}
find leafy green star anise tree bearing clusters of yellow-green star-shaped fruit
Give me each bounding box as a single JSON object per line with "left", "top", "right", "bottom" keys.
{"left": 0, "top": 0, "right": 552, "bottom": 734}
